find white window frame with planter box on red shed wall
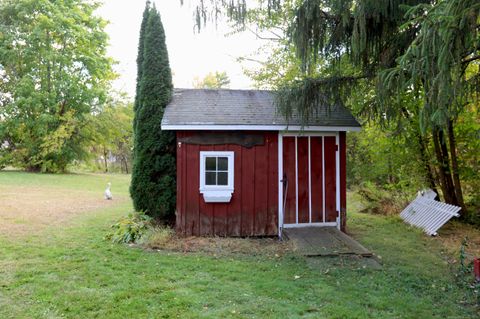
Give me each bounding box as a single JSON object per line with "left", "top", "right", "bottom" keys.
{"left": 200, "top": 151, "right": 235, "bottom": 202}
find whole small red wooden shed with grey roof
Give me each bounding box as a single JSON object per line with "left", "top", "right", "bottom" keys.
{"left": 162, "top": 89, "right": 360, "bottom": 236}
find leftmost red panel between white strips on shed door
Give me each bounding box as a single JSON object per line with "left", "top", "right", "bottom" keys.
{"left": 283, "top": 137, "right": 297, "bottom": 224}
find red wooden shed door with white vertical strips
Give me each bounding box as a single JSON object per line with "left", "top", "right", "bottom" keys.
{"left": 282, "top": 136, "right": 338, "bottom": 227}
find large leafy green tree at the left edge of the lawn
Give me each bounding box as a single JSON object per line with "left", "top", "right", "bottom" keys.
{"left": 0, "top": 0, "right": 115, "bottom": 172}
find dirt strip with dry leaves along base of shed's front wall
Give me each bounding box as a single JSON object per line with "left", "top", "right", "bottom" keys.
{"left": 139, "top": 228, "right": 294, "bottom": 257}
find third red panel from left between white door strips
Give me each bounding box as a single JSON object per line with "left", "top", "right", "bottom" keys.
{"left": 310, "top": 136, "right": 323, "bottom": 223}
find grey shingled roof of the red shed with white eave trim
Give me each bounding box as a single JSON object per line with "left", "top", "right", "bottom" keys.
{"left": 162, "top": 89, "right": 360, "bottom": 131}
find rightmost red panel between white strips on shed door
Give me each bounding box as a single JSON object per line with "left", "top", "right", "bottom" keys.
{"left": 324, "top": 136, "right": 337, "bottom": 223}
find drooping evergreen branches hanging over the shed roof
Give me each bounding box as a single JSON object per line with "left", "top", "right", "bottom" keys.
{"left": 190, "top": 0, "right": 480, "bottom": 125}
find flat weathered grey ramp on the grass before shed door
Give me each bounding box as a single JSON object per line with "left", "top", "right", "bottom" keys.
{"left": 283, "top": 227, "right": 373, "bottom": 257}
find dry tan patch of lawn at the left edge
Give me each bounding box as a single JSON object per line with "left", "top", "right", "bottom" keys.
{"left": 0, "top": 186, "right": 119, "bottom": 236}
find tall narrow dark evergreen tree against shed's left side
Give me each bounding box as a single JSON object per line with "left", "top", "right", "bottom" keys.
{"left": 130, "top": 3, "right": 176, "bottom": 220}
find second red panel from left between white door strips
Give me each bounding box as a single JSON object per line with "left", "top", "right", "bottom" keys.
{"left": 297, "top": 137, "right": 310, "bottom": 223}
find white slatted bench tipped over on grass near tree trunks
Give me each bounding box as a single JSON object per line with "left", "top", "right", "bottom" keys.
{"left": 400, "top": 190, "right": 461, "bottom": 236}
